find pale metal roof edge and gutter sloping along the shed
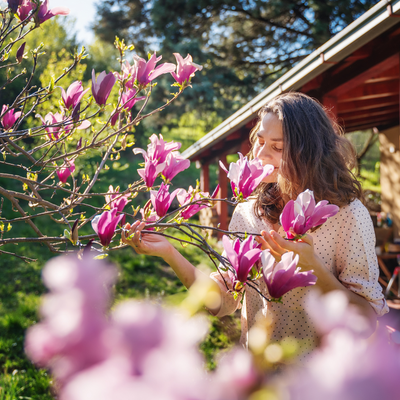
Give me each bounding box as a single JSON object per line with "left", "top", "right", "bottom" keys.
{"left": 182, "top": 0, "right": 400, "bottom": 158}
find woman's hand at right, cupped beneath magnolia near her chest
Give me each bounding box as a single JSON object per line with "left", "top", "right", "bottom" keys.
{"left": 256, "top": 230, "right": 322, "bottom": 271}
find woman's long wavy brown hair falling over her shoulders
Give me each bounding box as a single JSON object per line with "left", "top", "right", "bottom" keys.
{"left": 249, "top": 92, "right": 363, "bottom": 224}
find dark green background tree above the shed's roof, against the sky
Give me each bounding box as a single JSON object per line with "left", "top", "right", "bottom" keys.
{"left": 94, "top": 0, "right": 377, "bottom": 122}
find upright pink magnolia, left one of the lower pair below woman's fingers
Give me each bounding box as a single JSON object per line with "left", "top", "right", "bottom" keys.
{"left": 222, "top": 235, "right": 262, "bottom": 288}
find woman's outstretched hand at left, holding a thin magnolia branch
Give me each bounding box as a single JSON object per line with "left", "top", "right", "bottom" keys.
{"left": 121, "top": 221, "right": 173, "bottom": 258}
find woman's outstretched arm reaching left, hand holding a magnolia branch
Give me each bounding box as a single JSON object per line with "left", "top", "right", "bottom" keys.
{"left": 121, "top": 221, "right": 220, "bottom": 314}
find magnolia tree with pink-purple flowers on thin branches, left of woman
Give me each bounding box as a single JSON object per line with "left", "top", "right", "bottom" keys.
{"left": 0, "top": 0, "right": 337, "bottom": 300}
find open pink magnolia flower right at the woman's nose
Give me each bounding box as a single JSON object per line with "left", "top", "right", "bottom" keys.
{"left": 219, "top": 153, "right": 274, "bottom": 199}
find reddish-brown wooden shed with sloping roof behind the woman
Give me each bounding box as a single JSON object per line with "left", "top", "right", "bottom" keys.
{"left": 183, "top": 0, "right": 400, "bottom": 237}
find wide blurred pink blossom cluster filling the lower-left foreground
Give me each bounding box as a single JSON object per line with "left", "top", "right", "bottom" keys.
{"left": 25, "top": 256, "right": 257, "bottom": 400}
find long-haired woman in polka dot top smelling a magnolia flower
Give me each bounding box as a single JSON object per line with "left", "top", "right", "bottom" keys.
{"left": 123, "top": 93, "right": 388, "bottom": 354}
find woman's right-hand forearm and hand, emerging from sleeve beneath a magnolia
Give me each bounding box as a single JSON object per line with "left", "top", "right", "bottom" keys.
{"left": 258, "top": 231, "right": 377, "bottom": 330}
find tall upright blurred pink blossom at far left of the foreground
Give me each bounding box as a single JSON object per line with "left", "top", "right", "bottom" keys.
{"left": 25, "top": 256, "right": 117, "bottom": 384}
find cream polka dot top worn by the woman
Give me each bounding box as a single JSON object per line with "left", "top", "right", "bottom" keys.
{"left": 211, "top": 199, "right": 388, "bottom": 349}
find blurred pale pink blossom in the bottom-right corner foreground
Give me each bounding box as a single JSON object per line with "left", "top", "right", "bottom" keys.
{"left": 282, "top": 329, "right": 400, "bottom": 400}
